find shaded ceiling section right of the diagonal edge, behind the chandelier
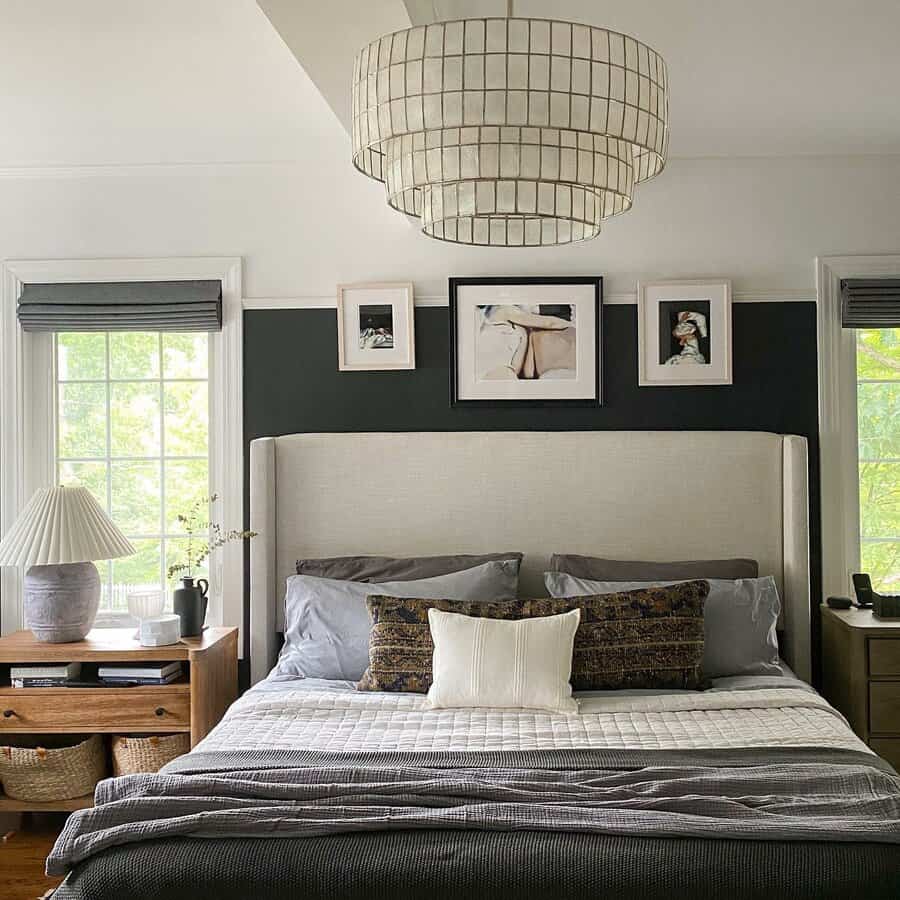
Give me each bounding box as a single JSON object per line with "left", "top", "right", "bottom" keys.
{"left": 259, "top": 0, "right": 900, "bottom": 158}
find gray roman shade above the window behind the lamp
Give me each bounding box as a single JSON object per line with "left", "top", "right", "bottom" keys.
{"left": 17, "top": 280, "right": 222, "bottom": 331}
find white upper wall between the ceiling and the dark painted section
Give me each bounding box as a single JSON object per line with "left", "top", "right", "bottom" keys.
{"left": 0, "top": 155, "right": 900, "bottom": 297}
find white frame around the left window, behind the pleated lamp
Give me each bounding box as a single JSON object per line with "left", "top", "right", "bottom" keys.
{"left": 0, "top": 257, "right": 244, "bottom": 647}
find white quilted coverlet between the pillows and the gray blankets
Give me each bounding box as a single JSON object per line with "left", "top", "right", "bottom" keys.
{"left": 195, "top": 682, "right": 868, "bottom": 751}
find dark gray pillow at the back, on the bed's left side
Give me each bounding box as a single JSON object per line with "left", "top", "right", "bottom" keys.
{"left": 297, "top": 553, "right": 522, "bottom": 584}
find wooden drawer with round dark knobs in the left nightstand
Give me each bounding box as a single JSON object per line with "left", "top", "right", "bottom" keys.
{"left": 0, "top": 684, "right": 191, "bottom": 736}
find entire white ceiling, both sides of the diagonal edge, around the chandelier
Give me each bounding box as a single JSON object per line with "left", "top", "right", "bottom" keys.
{"left": 0, "top": 0, "right": 900, "bottom": 171}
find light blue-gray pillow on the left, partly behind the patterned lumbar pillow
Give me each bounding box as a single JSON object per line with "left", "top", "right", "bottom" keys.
{"left": 275, "top": 559, "right": 519, "bottom": 681}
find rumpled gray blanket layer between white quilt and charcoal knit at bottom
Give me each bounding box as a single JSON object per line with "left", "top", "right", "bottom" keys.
{"left": 47, "top": 750, "right": 900, "bottom": 880}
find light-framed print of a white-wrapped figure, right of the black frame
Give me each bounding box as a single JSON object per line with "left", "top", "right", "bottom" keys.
{"left": 638, "top": 281, "right": 731, "bottom": 387}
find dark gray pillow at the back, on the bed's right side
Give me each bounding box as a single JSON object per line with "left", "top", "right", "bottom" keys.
{"left": 550, "top": 553, "right": 759, "bottom": 581}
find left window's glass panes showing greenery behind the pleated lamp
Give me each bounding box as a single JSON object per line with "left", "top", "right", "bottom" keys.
{"left": 55, "top": 332, "right": 210, "bottom": 618}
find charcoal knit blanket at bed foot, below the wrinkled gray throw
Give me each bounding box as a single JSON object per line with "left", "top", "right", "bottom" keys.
{"left": 53, "top": 831, "right": 900, "bottom": 900}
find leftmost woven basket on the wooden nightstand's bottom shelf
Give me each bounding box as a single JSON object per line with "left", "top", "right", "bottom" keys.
{"left": 0, "top": 734, "right": 106, "bottom": 803}
